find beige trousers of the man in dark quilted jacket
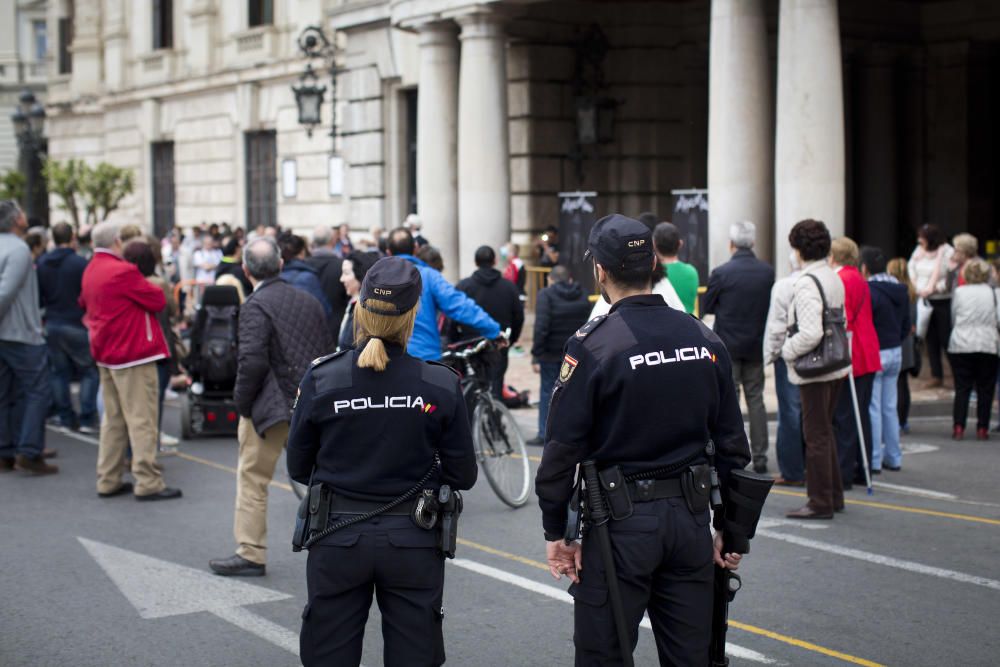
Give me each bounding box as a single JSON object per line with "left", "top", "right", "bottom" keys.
{"left": 233, "top": 417, "right": 288, "bottom": 565}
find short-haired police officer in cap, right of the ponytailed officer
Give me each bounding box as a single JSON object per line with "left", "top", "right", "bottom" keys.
{"left": 536, "top": 215, "right": 750, "bottom": 666}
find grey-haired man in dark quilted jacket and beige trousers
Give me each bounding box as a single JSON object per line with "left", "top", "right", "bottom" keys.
{"left": 208, "top": 232, "right": 334, "bottom": 576}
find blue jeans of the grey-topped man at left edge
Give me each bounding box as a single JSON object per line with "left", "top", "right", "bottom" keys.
{"left": 0, "top": 341, "right": 52, "bottom": 459}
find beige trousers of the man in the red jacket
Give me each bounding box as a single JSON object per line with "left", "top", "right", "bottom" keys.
{"left": 97, "top": 362, "right": 166, "bottom": 496}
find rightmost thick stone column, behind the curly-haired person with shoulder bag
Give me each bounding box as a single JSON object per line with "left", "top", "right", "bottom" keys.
{"left": 774, "top": 0, "right": 845, "bottom": 275}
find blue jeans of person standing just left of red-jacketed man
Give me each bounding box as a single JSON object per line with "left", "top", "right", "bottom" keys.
{"left": 45, "top": 322, "right": 100, "bottom": 428}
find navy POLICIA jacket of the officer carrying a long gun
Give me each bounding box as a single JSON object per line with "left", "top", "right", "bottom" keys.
{"left": 535, "top": 294, "right": 750, "bottom": 535}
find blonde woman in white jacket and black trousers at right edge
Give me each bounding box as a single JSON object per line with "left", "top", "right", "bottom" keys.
{"left": 948, "top": 259, "right": 1000, "bottom": 440}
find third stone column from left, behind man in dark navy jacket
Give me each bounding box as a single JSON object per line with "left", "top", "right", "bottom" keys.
{"left": 708, "top": 0, "right": 774, "bottom": 268}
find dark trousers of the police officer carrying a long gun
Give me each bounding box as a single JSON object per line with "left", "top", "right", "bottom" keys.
{"left": 569, "top": 498, "right": 715, "bottom": 667}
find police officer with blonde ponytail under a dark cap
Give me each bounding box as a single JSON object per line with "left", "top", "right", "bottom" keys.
{"left": 287, "top": 257, "right": 477, "bottom": 667}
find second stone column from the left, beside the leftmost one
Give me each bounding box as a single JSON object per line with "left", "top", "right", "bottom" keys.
{"left": 456, "top": 12, "right": 510, "bottom": 276}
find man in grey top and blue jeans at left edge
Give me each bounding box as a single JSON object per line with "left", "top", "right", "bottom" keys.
{"left": 0, "top": 201, "right": 59, "bottom": 475}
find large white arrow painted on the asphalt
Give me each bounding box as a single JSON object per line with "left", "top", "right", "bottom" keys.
{"left": 76, "top": 537, "right": 299, "bottom": 655}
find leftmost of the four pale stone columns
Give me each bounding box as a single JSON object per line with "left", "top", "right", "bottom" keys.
{"left": 417, "top": 22, "right": 459, "bottom": 281}
